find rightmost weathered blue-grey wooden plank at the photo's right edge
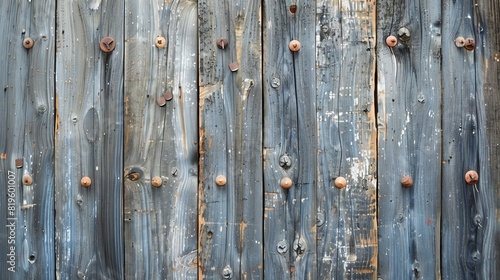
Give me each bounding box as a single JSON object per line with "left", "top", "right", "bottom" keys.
{"left": 441, "top": 1, "right": 500, "bottom": 279}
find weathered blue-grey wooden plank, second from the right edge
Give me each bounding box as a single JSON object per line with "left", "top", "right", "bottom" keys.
{"left": 377, "top": 0, "right": 446, "bottom": 279}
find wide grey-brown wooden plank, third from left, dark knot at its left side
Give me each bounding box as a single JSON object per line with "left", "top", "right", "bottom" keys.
{"left": 124, "top": 0, "right": 198, "bottom": 279}
